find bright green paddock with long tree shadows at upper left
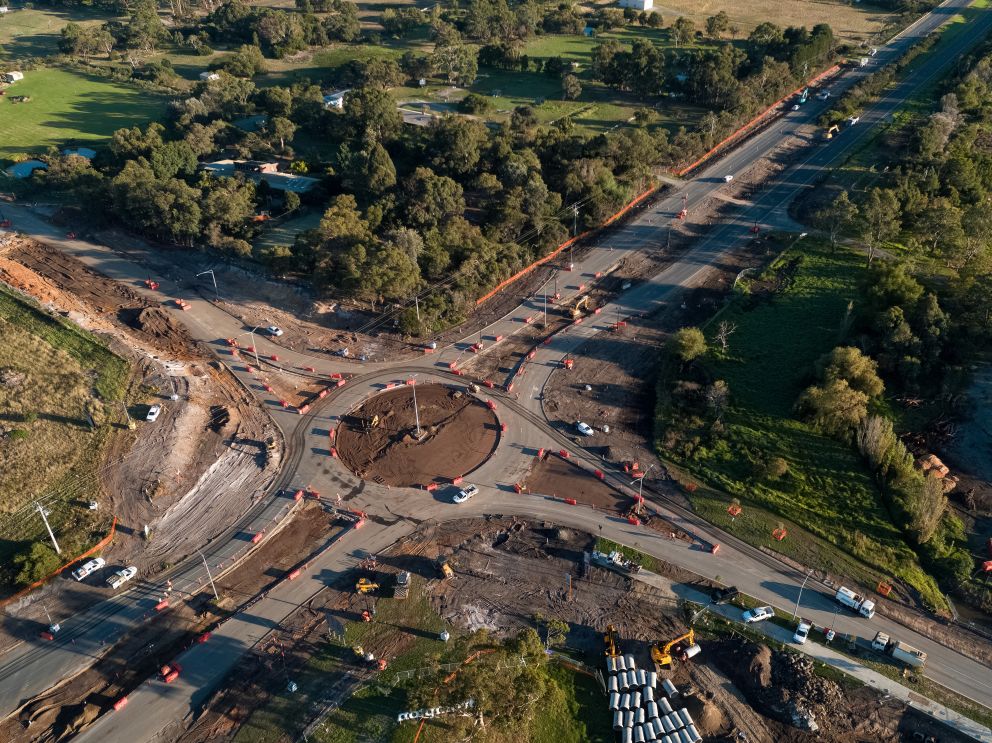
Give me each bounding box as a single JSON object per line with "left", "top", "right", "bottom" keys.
{"left": 0, "top": 68, "right": 166, "bottom": 158}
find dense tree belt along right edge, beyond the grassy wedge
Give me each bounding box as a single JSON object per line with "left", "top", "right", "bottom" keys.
{"left": 804, "top": 32, "right": 992, "bottom": 611}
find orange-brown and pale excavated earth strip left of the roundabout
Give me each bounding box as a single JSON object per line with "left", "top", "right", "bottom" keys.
{"left": 0, "top": 234, "right": 281, "bottom": 648}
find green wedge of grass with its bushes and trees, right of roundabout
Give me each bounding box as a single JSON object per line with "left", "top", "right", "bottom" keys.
{"left": 657, "top": 239, "right": 946, "bottom": 611}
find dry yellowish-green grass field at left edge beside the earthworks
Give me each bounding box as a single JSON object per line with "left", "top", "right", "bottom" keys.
{"left": 0, "top": 290, "right": 129, "bottom": 590}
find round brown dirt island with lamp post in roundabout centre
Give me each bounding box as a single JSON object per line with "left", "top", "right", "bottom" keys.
{"left": 335, "top": 384, "right": 499, "bottom": 487}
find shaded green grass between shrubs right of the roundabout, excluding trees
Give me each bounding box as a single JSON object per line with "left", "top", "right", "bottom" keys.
{"left": 660, "top": 240, "right": 946, "bottom": 608}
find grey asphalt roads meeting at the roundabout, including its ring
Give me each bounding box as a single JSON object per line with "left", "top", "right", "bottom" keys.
{"left": 0, "top": 0, "right": 992, "bottom": 741}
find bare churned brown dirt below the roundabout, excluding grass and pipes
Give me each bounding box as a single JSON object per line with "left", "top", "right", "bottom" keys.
{"left": 180, "top": 517, "right": 963, "bottom": 743}
